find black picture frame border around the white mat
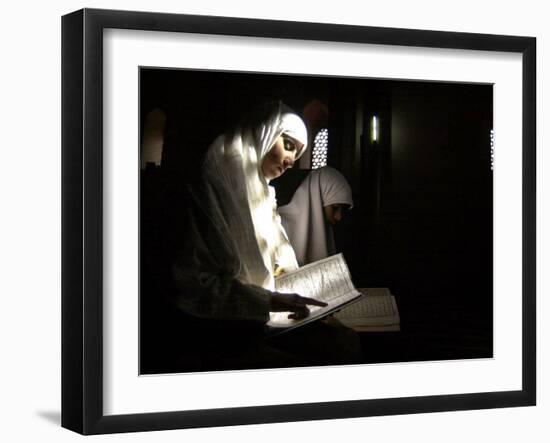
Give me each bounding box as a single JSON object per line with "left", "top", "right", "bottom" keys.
{"left": 62, "top": 9, "right": 536, "bottom": 434}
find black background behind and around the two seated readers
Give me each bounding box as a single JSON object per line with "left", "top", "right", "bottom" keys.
{"left": 140, "top": 68, "right": 493, "bottom": 372}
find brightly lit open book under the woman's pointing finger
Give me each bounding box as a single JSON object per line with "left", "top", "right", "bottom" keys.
{"left": 267, "top": 254, "right": 361, "bottom": 333}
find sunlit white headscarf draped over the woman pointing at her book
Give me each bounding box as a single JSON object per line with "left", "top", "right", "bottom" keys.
{"left": 199, "top": 102, "right": 307, "bottom": 289}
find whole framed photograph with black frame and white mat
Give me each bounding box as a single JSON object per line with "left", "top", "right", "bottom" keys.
{"left": 62, "top": 9, "right": 536, "bottom": 434}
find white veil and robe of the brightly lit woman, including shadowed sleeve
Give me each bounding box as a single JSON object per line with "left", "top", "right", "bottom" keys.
{"left": 175, "top": 104, "right": 307, "bottom": 320}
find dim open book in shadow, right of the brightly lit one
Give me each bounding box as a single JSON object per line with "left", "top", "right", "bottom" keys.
{"left": 334, "top": 288, "right": 401, "bottom": 332}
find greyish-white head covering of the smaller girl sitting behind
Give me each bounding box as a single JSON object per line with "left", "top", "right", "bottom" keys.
{"left": 279, "top": 166, "right": 353, "bottom": 266}
